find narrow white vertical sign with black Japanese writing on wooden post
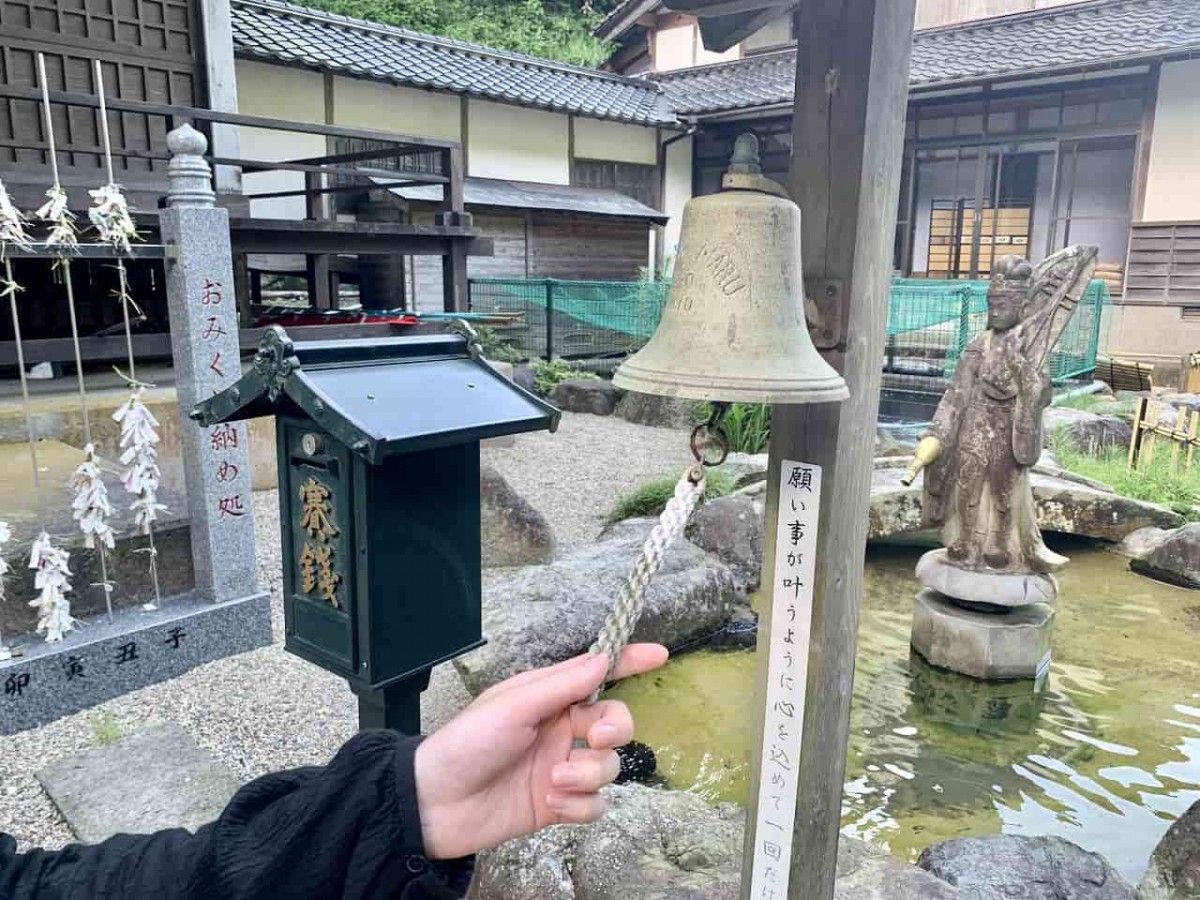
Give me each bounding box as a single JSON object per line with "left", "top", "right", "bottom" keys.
{"left": 750, "top": 460, "right": 821, "bottom": 900}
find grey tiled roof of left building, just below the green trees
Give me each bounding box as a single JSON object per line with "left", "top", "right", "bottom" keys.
{"left": 233, "top": 0, "right": 676, "bottom": 125}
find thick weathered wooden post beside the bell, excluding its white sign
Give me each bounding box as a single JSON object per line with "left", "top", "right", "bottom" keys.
{"left": 742, "top": 0, "right": 916, "bottom": 900}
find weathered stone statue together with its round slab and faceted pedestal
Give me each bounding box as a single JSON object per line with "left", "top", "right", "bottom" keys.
{"left": 905, "top": 247, "right": 1097, "bottom": 690}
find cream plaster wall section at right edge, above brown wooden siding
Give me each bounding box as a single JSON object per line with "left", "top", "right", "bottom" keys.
{"left": 1142, "top": 60, "right": 1200, "bottom": 222}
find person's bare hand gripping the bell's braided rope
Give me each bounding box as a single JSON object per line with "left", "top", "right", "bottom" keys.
{"left": 415, "top": 643, "right": 667, "bottom": 859}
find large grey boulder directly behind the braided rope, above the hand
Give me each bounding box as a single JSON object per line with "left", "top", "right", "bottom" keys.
{"left": 455, "top": 518, "right": 740, "bottom": 694}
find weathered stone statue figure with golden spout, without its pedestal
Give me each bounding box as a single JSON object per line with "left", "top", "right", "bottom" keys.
{"left": 906, "top": 246, "right": 1098, "bottom": 573}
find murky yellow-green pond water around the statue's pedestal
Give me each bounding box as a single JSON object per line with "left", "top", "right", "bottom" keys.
{"left": 611, "top": 542, "right": 1200, "bottom": 883}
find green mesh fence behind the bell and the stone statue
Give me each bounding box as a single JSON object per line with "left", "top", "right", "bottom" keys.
{"left": 470, "top": 278, "right": 1110, "bottom": 391}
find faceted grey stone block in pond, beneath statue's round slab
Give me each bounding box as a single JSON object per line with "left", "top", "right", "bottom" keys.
{"left": 912, "top": 590, "right": 1054, "bottom": 680}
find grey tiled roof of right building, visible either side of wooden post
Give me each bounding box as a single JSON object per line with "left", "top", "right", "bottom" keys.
{"left": 653, "top": 0, "right": 1200, "bottom": 115}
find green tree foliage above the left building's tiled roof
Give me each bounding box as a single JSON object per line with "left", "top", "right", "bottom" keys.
{"left": 307, "top": 0, "right": 619, "bottom": 66}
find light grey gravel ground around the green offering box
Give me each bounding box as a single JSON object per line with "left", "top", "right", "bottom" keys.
{"left": 0, "top": 413, "right": 690, "bottom": 848}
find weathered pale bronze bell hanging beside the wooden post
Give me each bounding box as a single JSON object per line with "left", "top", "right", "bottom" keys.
{"left": 613, "top": 134, "right": 850, "bottom": 403}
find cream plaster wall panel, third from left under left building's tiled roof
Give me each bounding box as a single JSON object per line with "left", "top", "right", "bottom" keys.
{"left": 467, "top": 100, "right": 571, "bottom": 185}
